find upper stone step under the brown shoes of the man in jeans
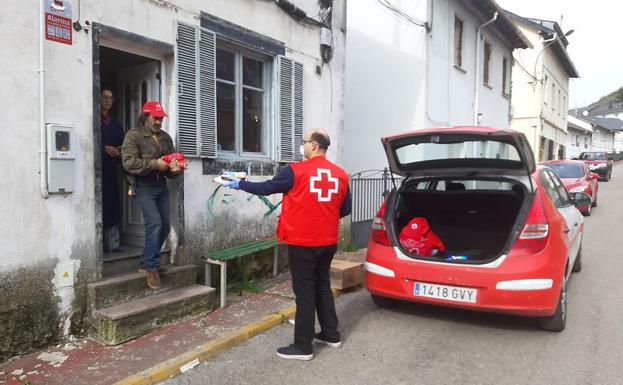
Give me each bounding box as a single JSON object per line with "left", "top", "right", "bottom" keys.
{"left": 87, "top": 265, "right": 197, "bottom": 311}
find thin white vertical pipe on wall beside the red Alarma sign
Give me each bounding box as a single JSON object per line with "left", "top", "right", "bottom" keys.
{"left": 39, "top": 0, "right": 50, "bottom": 199}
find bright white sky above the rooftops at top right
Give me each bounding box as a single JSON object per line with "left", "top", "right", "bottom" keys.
{"left": 496, "top": 0, "right": 623, "bottom": 109}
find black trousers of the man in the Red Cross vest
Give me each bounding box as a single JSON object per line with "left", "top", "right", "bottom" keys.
{"left": 288, "top": 245, "right": 340, "bottom": 354}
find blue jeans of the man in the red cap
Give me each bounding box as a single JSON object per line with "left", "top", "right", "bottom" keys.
{"left": 134, "top": 181, "right": 171, "bottom": 271}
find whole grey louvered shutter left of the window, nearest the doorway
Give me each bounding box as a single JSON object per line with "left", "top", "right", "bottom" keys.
{"left": 177, "top": 23, "right": 216, "bottom": 158}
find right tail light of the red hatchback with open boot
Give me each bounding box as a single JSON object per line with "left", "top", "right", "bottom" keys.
{"left": 510, "top": 192, "right": 549, "bottom": 255}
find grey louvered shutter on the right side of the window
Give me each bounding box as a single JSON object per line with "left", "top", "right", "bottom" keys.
{"left": 277, "top": 56, "right": 303, "bottom": 162}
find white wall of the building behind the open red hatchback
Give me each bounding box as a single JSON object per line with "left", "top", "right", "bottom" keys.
{"left": 344, "top": 0, "right": 512, "bottom": 173}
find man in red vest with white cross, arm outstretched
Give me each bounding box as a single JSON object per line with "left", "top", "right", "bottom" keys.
{"left": 226, "top": 129, "right": 351, "bottom": 361}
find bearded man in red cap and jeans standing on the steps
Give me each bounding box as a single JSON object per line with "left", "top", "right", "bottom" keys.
{"left": 121, "top": 101, "right": 183, "bottom": 290}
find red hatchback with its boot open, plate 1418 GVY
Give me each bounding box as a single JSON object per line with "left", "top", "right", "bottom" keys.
{"left": 365, "top": 127, "right": 591, "bottom": 331}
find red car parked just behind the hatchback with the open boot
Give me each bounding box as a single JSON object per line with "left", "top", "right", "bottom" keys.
{"left": 542, "top": 160, "right": 599, "bottom": 216}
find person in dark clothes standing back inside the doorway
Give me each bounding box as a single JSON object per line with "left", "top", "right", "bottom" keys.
{"left": 100, "top": 88, "right": 124, "bottom": 253}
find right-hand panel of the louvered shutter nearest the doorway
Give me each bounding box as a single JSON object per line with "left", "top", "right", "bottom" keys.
{"left": 199, "top": 28, "right": 216, "bottom": 158}
